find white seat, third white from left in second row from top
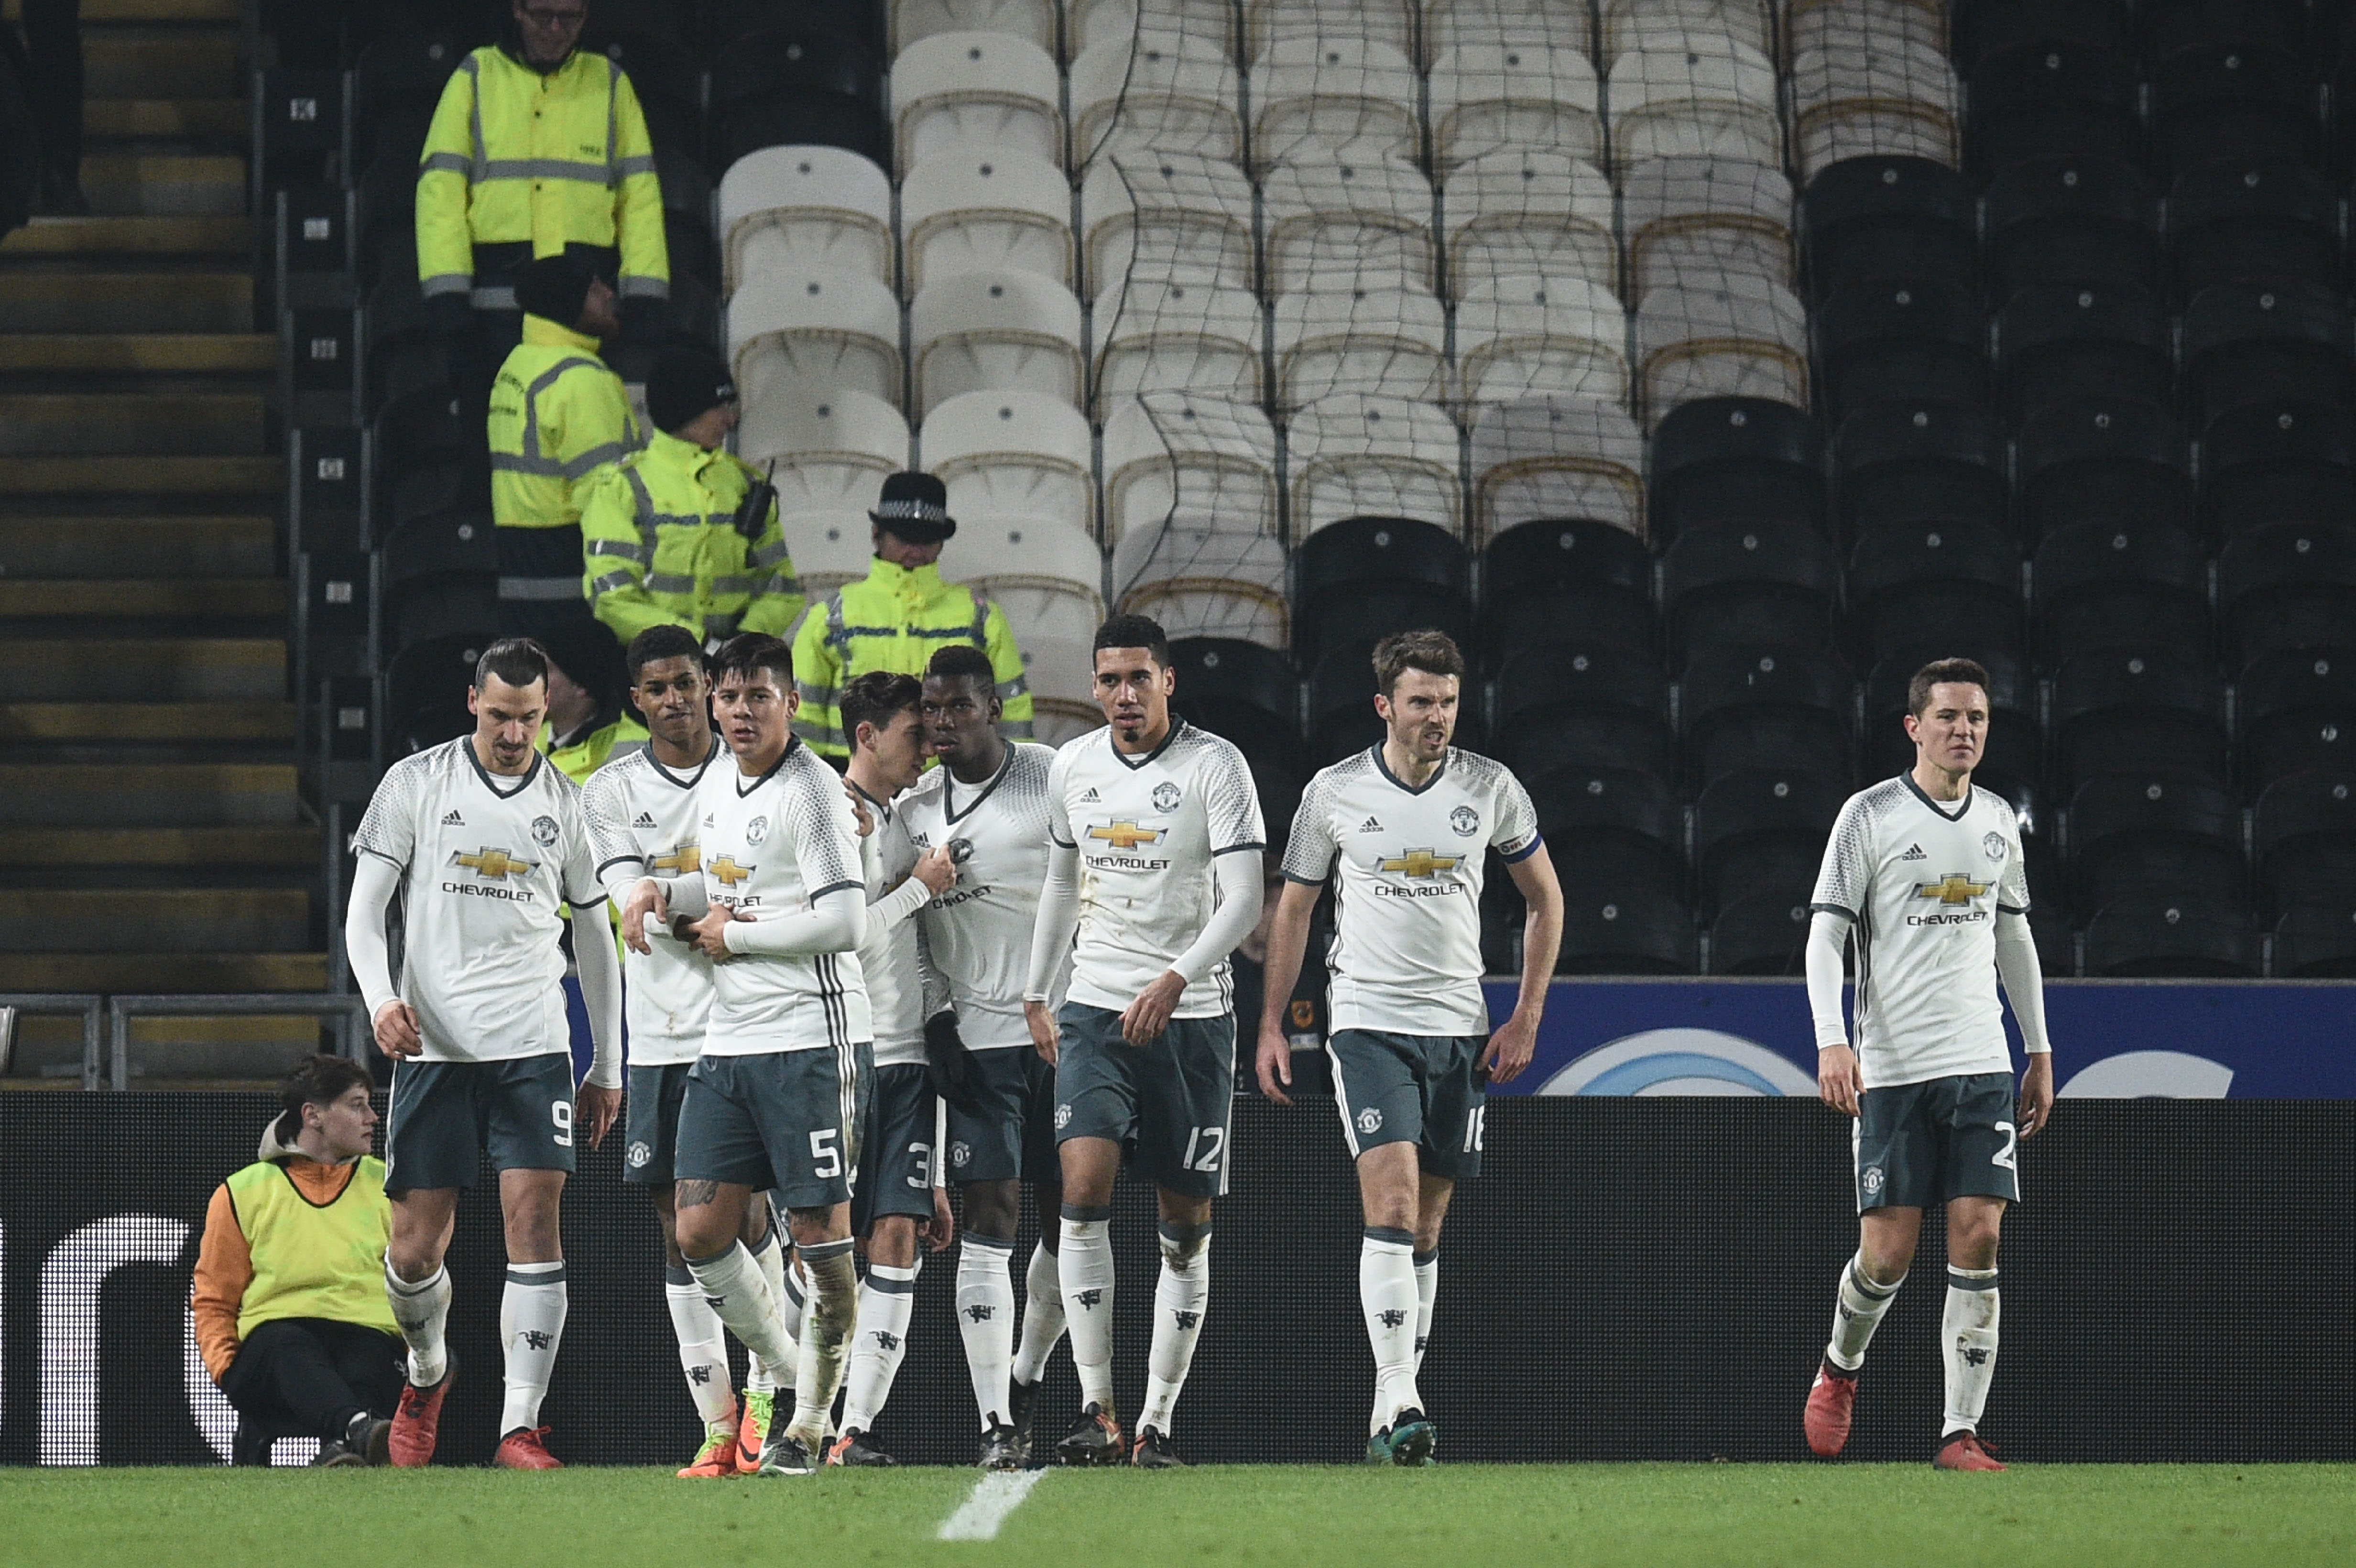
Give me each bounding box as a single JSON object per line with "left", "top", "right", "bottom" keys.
{"left": 1251, "top": 38, "right": 1423, "bottom": 174}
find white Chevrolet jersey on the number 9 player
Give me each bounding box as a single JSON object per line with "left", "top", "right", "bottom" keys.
{"left": 351, "top": 735, "right": 605, "bottom": 1062}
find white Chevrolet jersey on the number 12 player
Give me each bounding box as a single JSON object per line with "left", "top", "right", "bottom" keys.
{"left": 1048, "top": 718, "right": 1267, "bottom": 1017}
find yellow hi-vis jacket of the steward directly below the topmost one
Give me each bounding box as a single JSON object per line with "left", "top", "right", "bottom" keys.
{"left": 485, "top": 316, "right": 638, "bottom": 527}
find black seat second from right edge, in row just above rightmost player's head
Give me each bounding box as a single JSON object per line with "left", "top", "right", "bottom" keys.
{"left": 2031, "top": 520, "right": 2210, "bottom": 664}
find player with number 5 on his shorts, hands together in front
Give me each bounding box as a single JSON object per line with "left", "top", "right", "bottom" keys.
{"left": 622, "top": 633, "right": 874, "bottom": 1476}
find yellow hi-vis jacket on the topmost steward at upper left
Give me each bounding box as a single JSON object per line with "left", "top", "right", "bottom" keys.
{"left": 417, "top": 45, "right": 671, "bottom": 311}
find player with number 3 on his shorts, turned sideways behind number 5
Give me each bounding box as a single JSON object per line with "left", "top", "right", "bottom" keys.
{"left": 827, "top": 671, "right": 957, "bottom": 1464}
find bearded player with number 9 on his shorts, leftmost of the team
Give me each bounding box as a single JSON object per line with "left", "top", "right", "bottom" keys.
{"left": 344, "top": 638, "right": 622, "bottom": 1469}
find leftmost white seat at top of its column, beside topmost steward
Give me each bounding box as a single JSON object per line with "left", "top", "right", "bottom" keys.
{"left": 719, "top": 146, "right": 893, "bottom": 294}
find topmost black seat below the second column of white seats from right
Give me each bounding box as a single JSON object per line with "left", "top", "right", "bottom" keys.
{"left": 1647, "top": 398, "right": 1826, "bottom": 542}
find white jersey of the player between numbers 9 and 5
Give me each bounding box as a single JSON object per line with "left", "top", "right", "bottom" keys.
{"left": 582, "top": 741, "right": 733, "bottom": 1067}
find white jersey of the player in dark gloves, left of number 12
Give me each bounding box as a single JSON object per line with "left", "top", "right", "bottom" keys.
{"left": 900, "top": 741, "right": 1065, "bottom": 1050}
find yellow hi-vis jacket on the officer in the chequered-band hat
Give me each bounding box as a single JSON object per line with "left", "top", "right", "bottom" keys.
{"left": 794, "top": 555, "right": 1032, "bottom": 758}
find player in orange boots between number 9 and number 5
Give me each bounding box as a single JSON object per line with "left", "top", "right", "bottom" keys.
{"left": 582, "top": 626, "right": 796, "bottom": 1479}
